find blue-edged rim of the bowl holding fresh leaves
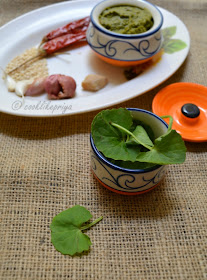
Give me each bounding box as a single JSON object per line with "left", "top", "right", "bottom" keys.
{"left": 90, "top": 108, "right": 168, "bottom": 174}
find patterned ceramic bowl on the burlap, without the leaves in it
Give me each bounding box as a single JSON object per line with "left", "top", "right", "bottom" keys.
{"left": 90, "top": 108, "right": 168, "bottom": 195}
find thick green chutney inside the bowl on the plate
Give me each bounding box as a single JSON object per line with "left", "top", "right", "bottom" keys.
{"left": 99, "top": 5, "right": 154, "bottom": 34}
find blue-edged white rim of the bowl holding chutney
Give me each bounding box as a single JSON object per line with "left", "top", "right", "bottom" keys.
{"left": 90, "top": 0, "right": 163, "bottom": 40}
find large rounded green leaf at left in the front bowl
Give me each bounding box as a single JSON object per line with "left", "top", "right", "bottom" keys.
{"left": 91, "top": 108, "right": 140, "bottom": 162}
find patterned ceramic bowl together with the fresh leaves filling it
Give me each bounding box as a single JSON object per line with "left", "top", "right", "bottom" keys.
{"left": 90, "top": 108, "right": 186, "bottom": 195}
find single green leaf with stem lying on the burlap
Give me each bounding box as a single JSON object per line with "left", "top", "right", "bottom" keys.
{"left": 50, "top": 205, "right": 102, "bottom": 256}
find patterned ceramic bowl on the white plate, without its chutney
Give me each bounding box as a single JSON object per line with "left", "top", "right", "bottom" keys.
{"left": 87, "top": 0, "right": 163, "bottom": 66}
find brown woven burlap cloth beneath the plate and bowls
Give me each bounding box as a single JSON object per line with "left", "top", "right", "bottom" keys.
{"left": 0, "top": 0, "right": 207, "bottom": 280}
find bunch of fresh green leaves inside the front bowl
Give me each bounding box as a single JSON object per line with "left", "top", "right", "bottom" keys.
{"left": 91, "top": 108, "right": 186, "bottom": 169}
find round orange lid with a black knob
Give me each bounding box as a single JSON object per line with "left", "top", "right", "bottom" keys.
{"left": 152, "top": 83, "right": 207, "bottom": 142}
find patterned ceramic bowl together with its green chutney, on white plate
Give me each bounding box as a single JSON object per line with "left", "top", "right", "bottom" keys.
{"left": 87, "top": 0, "right": 163, "bottom": 66}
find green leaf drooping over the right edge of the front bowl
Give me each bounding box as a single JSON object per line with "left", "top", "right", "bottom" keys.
{"left": 137, "top": 130, "right": 186, "bottom": 165}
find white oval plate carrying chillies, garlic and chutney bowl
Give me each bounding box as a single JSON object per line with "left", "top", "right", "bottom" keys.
{"left": 0, "top": 1, "right": 190, "bottom": 117}
